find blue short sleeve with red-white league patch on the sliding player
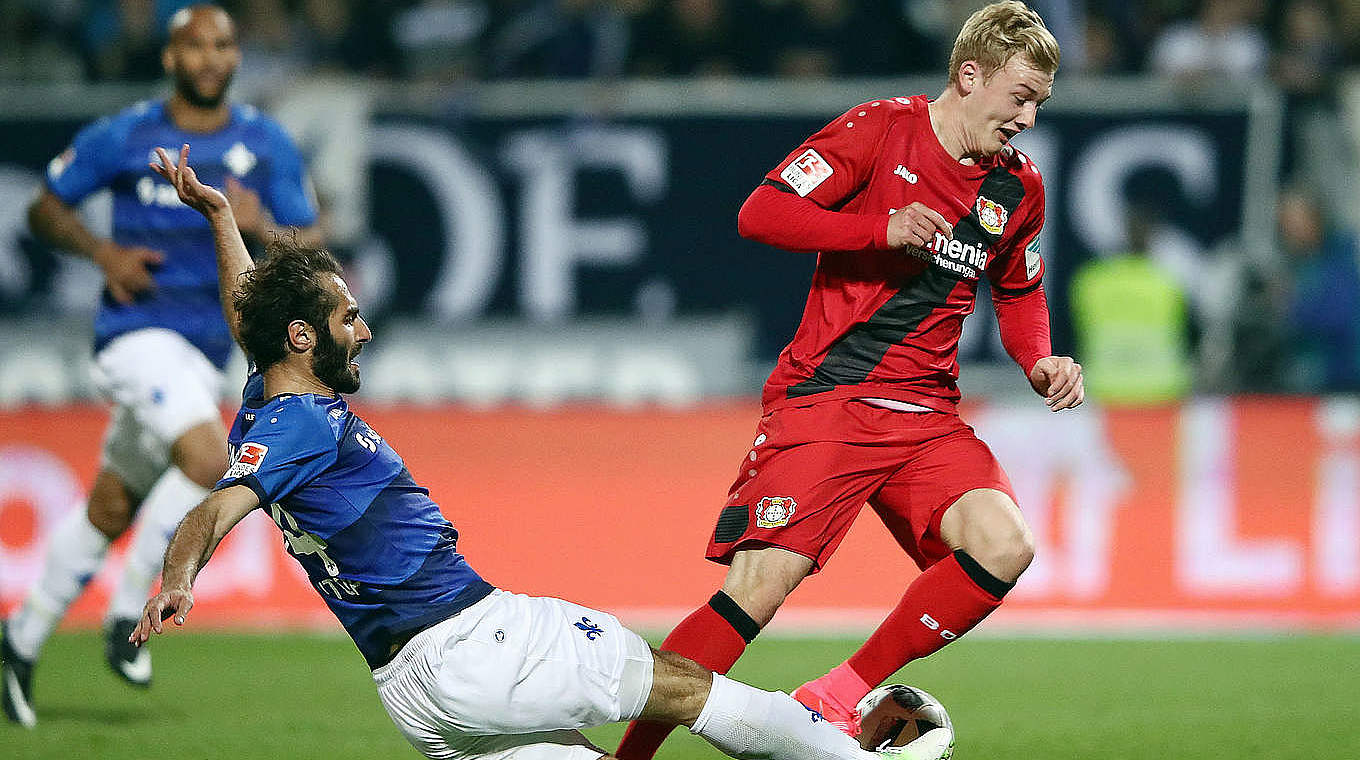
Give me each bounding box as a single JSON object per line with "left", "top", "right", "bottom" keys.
{"left": 214, "top": 405, "right": 339, "bottom": 504}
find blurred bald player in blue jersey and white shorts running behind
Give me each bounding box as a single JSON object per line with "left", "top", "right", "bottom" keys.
{"left": 0, "top": 5, "right": 318, "bottom": 726}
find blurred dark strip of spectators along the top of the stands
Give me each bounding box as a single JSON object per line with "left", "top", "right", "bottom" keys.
{"left": 0, "top": 0, "right": 1360, "bottom": 83}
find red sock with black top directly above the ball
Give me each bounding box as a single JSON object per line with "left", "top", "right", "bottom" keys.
{"left": 835, "top": 551, "right": 1015, "bottom": 706}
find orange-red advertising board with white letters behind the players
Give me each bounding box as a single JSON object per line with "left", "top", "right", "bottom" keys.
{"left": 0, "top": 398, "right": 1360, "bottom": 631}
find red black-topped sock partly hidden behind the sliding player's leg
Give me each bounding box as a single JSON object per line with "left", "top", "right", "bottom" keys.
{"left": 615, "top": 591, "right": 760, "bottom": 760}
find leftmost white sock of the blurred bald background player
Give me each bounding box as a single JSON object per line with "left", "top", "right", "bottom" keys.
{"left": 5, "top": 504, "right": 109, "bottom": 659}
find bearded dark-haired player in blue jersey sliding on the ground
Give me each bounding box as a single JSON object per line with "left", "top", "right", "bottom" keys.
{"left": 129, "top": 145, "right": 942, "bottom": 760}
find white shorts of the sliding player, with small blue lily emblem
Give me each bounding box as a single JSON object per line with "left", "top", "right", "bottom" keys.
{"left": 373, "top": 590, "right": 653, "bottom": 760}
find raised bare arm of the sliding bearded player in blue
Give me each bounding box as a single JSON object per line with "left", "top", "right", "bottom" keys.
{"left": 151, "top": 144, "right": 254, "bottom": 343}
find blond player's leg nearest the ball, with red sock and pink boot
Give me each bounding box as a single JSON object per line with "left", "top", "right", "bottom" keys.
{"left": 794, "top": 423, "right": 1034, "bottom": 723}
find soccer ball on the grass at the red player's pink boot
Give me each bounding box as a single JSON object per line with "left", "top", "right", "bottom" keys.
{"left": 855, "top": 684, "right": 953, "bottom": 760}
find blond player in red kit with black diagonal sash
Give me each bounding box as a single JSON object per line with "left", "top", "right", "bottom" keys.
{"left": 617, "top": 1, "right": 1084, "bottom": 760}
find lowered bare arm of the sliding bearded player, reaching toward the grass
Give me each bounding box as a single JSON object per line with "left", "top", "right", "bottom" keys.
{"left": 128, "top": 485, "right": 260, "bottom": 646}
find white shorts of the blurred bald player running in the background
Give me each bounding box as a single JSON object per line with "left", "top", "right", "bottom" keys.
{"left": 95, "top": 328, "right": 223, "bottom": 506}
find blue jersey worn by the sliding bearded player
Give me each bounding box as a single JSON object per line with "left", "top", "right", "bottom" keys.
{"left": 216, "top": 374, "right": 492, "bottom": 668}
